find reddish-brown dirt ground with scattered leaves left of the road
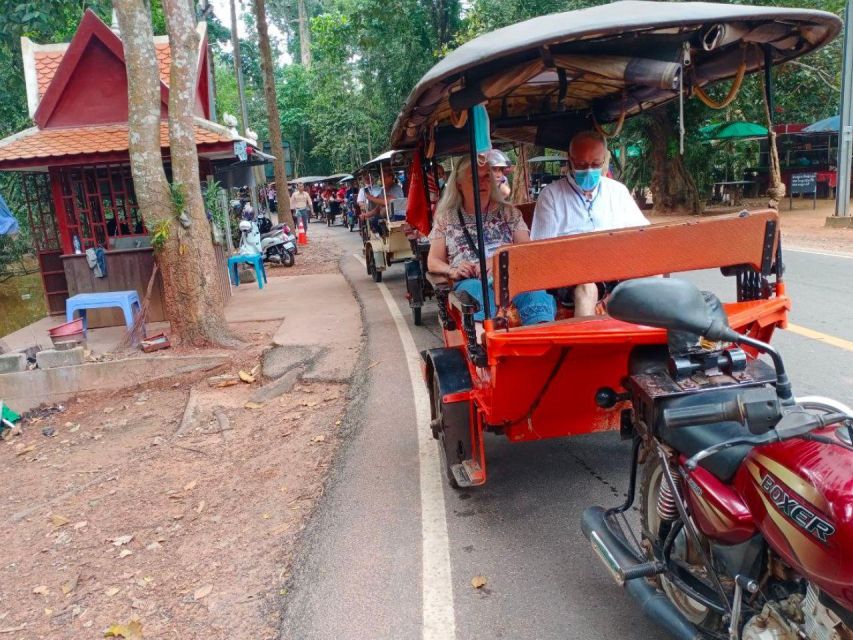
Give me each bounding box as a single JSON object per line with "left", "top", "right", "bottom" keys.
{"left": 0, "top": 242, "right": 356, "bottom": 640}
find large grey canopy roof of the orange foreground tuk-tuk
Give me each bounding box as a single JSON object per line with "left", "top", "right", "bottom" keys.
{"left": 391, "top": 0, "right": 841, "bottom": 148}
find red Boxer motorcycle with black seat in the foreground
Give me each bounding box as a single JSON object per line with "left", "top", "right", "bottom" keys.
{"left": 583, "top": 278, "right": 853, "bottom": 640}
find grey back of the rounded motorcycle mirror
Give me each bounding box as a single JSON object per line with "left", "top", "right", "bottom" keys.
{"left": 607, "top": 278, "right": 738, "bottom": 341}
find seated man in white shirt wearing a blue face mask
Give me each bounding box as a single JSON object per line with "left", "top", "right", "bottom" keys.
{"left": 530, "top": 131, "right": 649, "bottom": 317}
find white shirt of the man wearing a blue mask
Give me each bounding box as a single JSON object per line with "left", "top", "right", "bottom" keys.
{"left": 530, "top": 176, "right": 649, "bottom": 240}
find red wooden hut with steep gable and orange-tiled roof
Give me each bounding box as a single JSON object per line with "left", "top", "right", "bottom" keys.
{"left": 0, "top": 10, "right": 243, "bottom": 326}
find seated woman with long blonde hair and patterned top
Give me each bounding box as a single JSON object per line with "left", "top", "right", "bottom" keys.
{"left": 427, "top": 153, "right": 556, "bottom": 324}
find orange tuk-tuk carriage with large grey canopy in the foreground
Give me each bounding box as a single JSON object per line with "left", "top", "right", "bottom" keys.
{"left": 390, "top": 1, "right": 837, "bottom": 487}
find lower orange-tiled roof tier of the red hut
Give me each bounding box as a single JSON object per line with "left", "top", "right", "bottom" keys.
{"left": 0, "top": 118, "right": 240, "bottom": 169}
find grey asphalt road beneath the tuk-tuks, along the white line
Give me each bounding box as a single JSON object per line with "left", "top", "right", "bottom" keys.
{"left": 282, "top": 225, "right": 853, "bottom": 640}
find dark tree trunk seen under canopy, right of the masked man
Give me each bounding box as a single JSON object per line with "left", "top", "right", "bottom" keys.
{"left": 648, "top": 107, "right": 702, "bottom": 215}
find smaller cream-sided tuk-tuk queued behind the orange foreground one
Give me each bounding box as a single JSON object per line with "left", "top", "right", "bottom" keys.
{"left": 356, "top": 150, "right": 414, "bottom": 282}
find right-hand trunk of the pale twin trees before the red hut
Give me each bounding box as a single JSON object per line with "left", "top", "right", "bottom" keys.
{"left": 161, "top": 0, "right": 231, "bottom": 346}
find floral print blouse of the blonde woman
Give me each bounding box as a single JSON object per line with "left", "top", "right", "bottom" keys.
{"left": 429, "top": 204, "right": 527, "bottom": 267}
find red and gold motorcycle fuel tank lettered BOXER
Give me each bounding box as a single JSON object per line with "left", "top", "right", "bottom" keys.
{"left": 735, "top": 428, "right": 853, "bottom": 611}
